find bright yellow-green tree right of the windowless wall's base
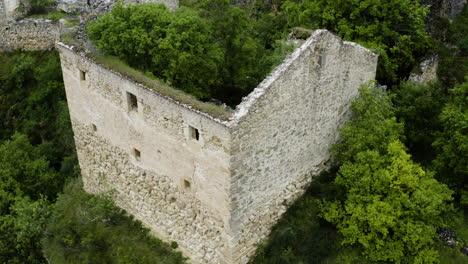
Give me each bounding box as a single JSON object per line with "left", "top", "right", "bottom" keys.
{"left": 322, "top": 87, "right": 452, "bottom": 263}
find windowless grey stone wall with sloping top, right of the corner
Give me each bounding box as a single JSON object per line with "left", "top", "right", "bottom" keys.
{"left": 230, "top": 30, "right": 377, "bottom": 263}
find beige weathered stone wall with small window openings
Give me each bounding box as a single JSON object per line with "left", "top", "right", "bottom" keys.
{"left": 57, "top": 44, "right": 230, "bottom": 263}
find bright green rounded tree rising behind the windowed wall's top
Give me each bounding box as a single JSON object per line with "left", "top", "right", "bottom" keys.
{"left": 88, "top": 2, "right": 222, "bottom": 99}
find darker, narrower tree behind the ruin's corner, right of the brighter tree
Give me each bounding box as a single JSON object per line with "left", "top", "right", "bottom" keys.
{"left": 199, "top": 0, "right": 266, "bottom": 104}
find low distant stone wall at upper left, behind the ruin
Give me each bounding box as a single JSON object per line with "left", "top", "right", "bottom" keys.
{"left": 0, "top": 18, "right": 60, "bottom": 51}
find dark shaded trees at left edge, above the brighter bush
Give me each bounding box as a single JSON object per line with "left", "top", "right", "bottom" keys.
{"left": 0, "top": 52, "right": 76, "bottom": 177}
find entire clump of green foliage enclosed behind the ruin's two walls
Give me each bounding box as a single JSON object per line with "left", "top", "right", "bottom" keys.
{"left": 88, "top": 0, "right": 291, "bottom": 104}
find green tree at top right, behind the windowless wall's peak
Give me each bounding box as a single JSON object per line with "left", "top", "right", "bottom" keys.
{"left": 282, "top": 0, "right": 429, "bottom": 84}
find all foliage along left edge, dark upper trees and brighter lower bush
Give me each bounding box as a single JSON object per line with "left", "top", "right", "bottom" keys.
{"left": 0, "top": 52, "right": 77, "bottom": 263}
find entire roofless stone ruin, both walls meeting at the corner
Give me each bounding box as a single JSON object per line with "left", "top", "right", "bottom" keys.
{"left": 57, "top": 30, "right": 377, "bottom": 264}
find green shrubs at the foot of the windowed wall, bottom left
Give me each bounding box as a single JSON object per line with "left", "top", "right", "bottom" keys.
{"left": 43, "top": 183, "right": 185, "bottom": 264}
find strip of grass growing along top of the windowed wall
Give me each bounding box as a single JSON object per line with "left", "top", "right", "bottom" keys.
{"left": 87, "top": 54, "right": 231, "bottom": 120}
